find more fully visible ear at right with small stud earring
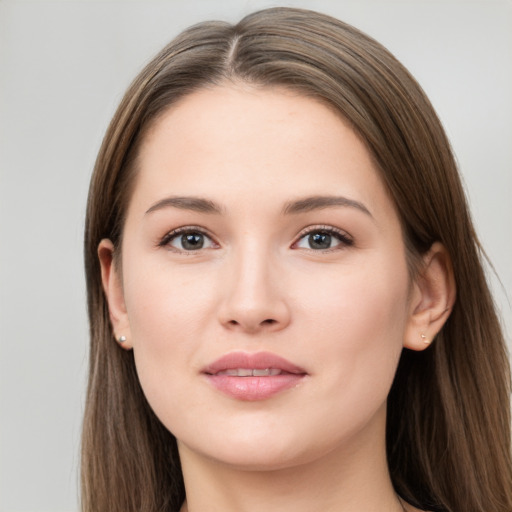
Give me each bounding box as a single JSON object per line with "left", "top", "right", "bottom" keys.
{"left": 404, "top": 242, "right": 456, "bottom": 350}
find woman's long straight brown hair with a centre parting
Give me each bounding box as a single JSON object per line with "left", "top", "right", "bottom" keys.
{"left": 82, "top": 8, "right": 512, "bottom": 512}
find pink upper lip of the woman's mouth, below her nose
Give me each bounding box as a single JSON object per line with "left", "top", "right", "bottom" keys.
{"left": 203, "top": 352, "right": 307, "bottom": 375}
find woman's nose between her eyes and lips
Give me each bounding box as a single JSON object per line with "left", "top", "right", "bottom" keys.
{"left": 219, "top": 245, "right": 290, "bottom": 334}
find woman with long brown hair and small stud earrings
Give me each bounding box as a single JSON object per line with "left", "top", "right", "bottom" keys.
{"left": 82, "top": 9, "right": 512, "bottom": 512}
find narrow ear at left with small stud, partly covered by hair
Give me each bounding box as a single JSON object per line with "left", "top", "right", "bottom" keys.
{"left": 98, "top": 238, "right": 133, "bottom": 350}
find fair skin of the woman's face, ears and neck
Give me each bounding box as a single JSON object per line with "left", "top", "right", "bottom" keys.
{"left": 99, "top": 85, "right": 454, "bottom": 512}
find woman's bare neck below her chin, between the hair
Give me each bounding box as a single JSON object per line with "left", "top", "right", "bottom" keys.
{"left": 179, "top": 410, "right": 405, "bottom": 512}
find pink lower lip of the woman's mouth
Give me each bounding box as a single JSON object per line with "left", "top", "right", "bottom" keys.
{"left": 206, "top": 373, "right": 305, "bottom": 401}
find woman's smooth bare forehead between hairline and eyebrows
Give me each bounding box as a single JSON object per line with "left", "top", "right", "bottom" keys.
{"left": 134, "top": 85, "right": 387, "bottom": 218}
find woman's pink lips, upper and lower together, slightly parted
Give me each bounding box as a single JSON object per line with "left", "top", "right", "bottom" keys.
{"left": 202, "top": 352, "right": 307, "bottom": 401}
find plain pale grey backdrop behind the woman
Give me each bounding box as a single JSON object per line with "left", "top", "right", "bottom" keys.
{"left": 0, "top": 0, "right": 512, "bottom": 512}
